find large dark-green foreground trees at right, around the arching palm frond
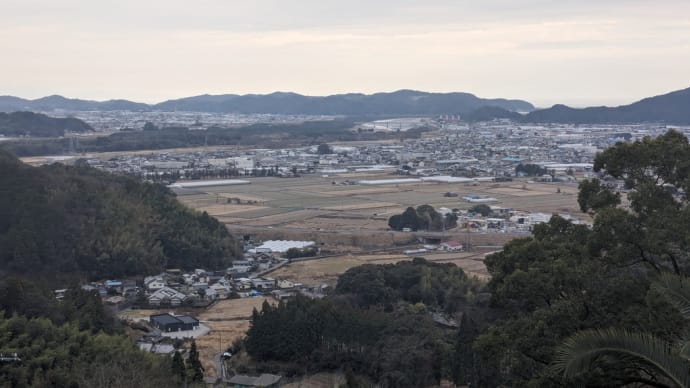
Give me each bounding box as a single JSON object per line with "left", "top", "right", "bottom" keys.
{"left": 474, "top": 131, "right": 690, "bottom": 387}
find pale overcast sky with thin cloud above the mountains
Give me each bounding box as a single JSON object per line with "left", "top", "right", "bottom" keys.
{"left": 0, "top": 0, "right": 690, "bottom": 106}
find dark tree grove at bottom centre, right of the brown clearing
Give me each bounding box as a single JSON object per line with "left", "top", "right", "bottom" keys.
{"left": 245, "top": 258, "right": 479, "bottom": 387}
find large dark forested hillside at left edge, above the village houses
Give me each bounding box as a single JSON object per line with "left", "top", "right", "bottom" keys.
{"left": 0, "top": 151, "right": 238, "bottom": 278}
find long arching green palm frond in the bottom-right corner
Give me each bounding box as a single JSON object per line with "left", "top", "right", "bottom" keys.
{"left": 553, "top": 329, "right": 690, "bottom": 388}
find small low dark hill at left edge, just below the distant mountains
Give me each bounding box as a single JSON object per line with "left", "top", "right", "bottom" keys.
{"left": 0, "top": 112, "right": 93, "bottom": 137}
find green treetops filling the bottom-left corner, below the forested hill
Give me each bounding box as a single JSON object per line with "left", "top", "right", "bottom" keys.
{"left": 0, "top": 275, "right": 177, "bottom": 387}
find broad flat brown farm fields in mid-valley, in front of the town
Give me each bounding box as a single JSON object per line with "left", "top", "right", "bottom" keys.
{"left": 179, "top": 174, "right": 588, "bottom": 243}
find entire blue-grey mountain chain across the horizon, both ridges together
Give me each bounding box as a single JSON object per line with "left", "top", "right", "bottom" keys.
{"left": 6, "top": 88, "right": 690, "bottom": 124}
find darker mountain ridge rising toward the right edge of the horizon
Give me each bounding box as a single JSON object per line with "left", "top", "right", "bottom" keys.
{"left": 466, "top": 88, "right": 690, "bottom": 124}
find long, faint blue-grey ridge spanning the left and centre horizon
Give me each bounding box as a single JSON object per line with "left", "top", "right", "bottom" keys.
{"left": 0, "top": 90, "right": 534, "bottom": 116}
